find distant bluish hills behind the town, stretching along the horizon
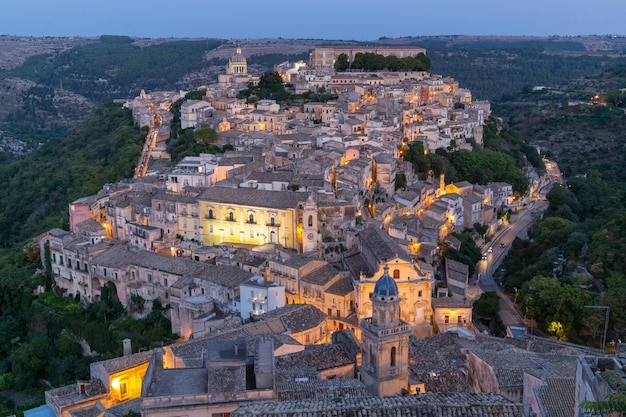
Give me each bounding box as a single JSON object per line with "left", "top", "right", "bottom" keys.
{"left": 0, "top": 36, "right": 626, "bottom": 156}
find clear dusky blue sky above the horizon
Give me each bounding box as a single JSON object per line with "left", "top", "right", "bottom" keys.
{"left": 0, "top": 0, "right": 626, "bottom": 40}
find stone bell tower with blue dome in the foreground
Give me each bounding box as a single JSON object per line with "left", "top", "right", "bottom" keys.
{"left": 360, "top": 265, "right": 411, "bottom": 396}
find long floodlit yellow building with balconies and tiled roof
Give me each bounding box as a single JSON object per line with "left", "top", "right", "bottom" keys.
{"left": 198, "top": 187, "right": 309, "bottom": 250}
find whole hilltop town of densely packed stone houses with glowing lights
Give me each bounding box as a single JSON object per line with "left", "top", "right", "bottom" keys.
{"left": 31, "top": 46, "right": 623, "bottom": 417}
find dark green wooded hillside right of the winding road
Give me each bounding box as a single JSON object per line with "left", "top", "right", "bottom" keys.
{"left": 492, "top": 66, "right": 626, "bottom": 345}
